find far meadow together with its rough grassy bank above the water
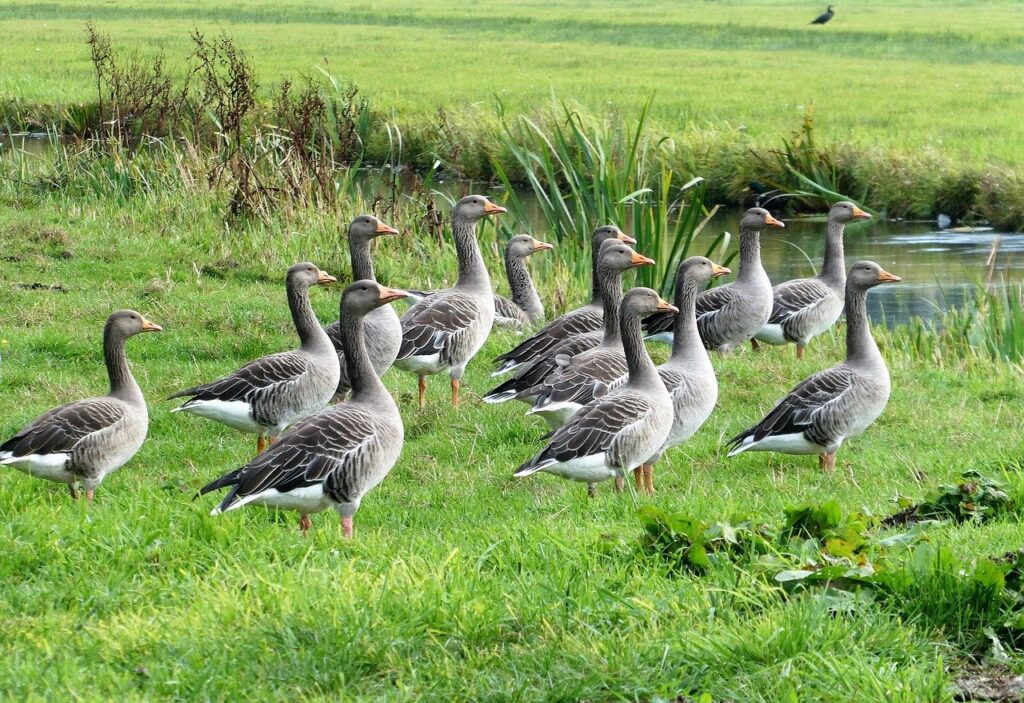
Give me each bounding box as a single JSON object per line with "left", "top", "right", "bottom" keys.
{"left": 6, "top": 0, "right": 1024, "bottom": 230}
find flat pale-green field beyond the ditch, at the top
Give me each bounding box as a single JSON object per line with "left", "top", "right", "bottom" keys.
{"left": 6, "top": 0, "right": 1024, "bottom": 166}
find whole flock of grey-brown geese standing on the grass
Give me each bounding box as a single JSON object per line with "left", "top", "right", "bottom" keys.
{"left": 0, "top": 195, "right": 900, "bottom": 537}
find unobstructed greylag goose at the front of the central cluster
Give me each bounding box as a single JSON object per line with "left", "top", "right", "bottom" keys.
{"left": 514, "top": 288, "right": 676, "bottom": 495}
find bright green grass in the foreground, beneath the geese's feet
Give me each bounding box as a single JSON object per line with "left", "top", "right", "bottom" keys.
{"left": 0, "top": 171, "right": 1024, "bottom": 701}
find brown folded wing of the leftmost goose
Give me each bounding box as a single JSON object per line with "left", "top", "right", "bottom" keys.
{"left": 0, "top": 398, "right": 125, "bottom": 456}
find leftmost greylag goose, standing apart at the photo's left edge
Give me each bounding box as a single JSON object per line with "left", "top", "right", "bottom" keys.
{"left": 0, "top": 310, "right": 161, "bottom": 500}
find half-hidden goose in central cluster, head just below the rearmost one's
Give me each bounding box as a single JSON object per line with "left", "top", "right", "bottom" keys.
{"left": 483, "top": 238, "right": 654, "bottom": 409}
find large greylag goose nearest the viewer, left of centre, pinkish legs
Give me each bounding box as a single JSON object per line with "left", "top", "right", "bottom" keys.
{"left": 200, "top": 280, "right": 407, "bottom": 537}
